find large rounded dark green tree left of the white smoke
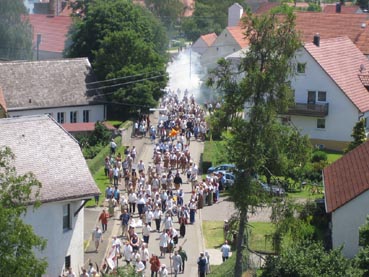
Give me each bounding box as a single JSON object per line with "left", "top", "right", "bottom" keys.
{"left": 65, "top": 0, "right": 168, "bottom": 115}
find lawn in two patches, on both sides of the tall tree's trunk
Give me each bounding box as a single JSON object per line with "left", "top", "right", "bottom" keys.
{"left": 202, "top": 220, "right": 274, "bottom": 252}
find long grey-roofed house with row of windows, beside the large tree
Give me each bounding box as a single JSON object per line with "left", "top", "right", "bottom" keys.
{"left": 0, "top": 58, "right": 106, "bottom": 123}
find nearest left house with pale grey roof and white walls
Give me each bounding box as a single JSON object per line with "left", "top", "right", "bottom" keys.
{"left": 0, "top": 115, "right": 100, "bottom": 276}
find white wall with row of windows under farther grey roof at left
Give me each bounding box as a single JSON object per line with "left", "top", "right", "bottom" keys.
{"left": 8, "top": 105, "right": 106, "bottom": 123}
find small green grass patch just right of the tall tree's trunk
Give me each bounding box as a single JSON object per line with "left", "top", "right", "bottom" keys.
{"left": 249, "top": 222, "right": 274, "bottom": 252}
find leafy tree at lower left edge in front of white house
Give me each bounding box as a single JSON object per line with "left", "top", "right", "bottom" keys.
{"left": 0, "top": 148, "right": 47, "bottom": 276}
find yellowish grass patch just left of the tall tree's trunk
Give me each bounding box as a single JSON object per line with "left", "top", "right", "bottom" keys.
{"left": 202, "top": 220, "right": 224, "bottom": 248}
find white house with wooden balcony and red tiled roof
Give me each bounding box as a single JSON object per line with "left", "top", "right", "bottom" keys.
{"left": 288, "top": 36, "right": 369, "bottom": 150}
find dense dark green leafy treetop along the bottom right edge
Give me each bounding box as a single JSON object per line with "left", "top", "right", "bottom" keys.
{"left": 261, "top": 242, "right": 362, "bottom": 277}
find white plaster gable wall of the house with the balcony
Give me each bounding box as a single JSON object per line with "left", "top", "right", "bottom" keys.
{"left": 291, "top": 49, "right": 359, "bottom": 141}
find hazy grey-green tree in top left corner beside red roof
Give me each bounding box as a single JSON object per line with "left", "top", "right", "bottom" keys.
{"left": 0, "top": 0, "right": 32, "bottom": 60}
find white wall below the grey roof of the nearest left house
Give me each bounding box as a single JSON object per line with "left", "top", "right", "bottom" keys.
{"left": 24, "top": 201, "right": 84, "bottom": 276}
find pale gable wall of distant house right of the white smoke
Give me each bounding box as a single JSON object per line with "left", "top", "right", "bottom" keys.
{"left": 200, "top": 29, "right": 241, "bottom": 69}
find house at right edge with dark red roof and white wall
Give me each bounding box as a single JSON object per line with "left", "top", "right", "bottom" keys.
{"left": 323, "top": 139, "right": 369, "bottom": 258}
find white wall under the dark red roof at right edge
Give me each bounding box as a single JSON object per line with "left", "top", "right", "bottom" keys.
{"left": 332, "top": 191, "right": 369, "bottom": 258}
